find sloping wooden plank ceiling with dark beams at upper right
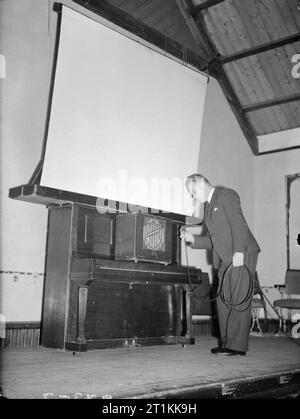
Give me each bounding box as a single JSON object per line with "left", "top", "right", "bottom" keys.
{"left": 75, "top": 0, "right": 300, "bottom": 155}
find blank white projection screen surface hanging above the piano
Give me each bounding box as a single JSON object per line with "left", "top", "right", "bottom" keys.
{"left": 41, "top": 7, "right": 207, "bottom": 215}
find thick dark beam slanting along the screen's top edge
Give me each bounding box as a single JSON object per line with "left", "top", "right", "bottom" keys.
{"left": 73, "top": 0, "right": 207, "bottom": 70}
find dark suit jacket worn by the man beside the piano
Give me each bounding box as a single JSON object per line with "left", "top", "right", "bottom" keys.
{"left": 192, "top": 187, "right": 260, "bottom": 268}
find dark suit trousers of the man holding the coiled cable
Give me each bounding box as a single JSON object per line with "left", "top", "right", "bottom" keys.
{"left": 217, "top": 252, "right": 258, "bottom": 352}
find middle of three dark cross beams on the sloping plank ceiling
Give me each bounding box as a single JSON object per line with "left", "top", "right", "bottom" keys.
{"left": 219, "top": 32, "right": 300, "bottom": 64}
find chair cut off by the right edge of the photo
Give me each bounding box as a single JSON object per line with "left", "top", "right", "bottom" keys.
{"left": 273, "top": 269, "right": 300, "bottom": 334}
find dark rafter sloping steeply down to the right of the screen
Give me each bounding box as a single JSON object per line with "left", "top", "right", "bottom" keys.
{"left": 180, "top": 0, "right": 258, "bottom": 155}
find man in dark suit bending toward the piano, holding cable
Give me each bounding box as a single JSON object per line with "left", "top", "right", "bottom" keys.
{"left": 181, "top": 174, "right": 260, "bottom": 356}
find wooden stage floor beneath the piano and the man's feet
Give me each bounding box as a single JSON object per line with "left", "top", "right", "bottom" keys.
{"left": 1, "top": 336, "right": 300, "bottom": 399}
